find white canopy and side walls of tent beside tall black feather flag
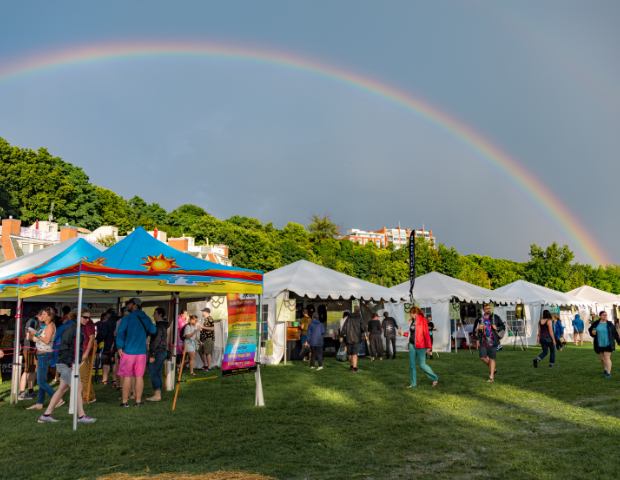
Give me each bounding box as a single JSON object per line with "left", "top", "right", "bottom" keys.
{"left": 388, "top": 272, "right": 519, "bottom": 352}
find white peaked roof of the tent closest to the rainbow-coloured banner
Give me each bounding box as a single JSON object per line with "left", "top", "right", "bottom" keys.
{"left": 264, "top": 260, "right": 409, "bottom": 302}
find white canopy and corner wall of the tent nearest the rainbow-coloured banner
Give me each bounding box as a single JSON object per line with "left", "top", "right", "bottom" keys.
{"left": 262, "top": 260, "right": 409, "bottom": 364}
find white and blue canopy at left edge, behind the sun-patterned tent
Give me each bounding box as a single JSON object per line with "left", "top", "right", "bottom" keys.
{"left": 0, "top": 238, "right": 106, "bottom": 300}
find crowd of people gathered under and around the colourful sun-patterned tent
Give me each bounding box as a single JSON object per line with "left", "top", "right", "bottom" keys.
{"left": 0, "top": 298, "right": 220, "bottom": 424}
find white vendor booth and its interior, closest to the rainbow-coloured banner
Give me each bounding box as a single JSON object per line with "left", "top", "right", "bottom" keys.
{"left": 263, "top": 260, "right": 409, "bottom": 364}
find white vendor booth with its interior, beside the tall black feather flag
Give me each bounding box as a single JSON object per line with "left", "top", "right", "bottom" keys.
{"left": 387, "top": 272, "right": 519, "bottom": 352}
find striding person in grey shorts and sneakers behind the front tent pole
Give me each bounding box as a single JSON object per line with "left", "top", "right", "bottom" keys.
{"left": 38, "top": 314, "right": 97, "bottom": 423}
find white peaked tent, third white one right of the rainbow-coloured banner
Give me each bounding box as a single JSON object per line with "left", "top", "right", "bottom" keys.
{"left": 495, "top": 280, "right": 593, "bottom": 345}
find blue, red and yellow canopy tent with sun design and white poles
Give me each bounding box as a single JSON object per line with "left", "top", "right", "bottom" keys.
{"left": 9, "top": 227, "right": 263, "bottom": 422}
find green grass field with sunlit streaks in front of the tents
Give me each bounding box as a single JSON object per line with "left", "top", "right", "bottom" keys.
{"left": 0, "top": 344, "right": 620, "bottom": 479}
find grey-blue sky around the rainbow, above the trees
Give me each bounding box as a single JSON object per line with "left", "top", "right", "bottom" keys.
{"left": 0, "top": 0, "right": 620, "bottom": 264}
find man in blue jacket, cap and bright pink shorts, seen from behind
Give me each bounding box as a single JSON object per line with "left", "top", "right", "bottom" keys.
{"left": 116, "top": 298, "right": 157, "bottom": 407}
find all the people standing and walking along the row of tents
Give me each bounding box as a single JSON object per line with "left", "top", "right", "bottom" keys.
{"left": 0, "top": 298, "right": 620, "bottom": 424}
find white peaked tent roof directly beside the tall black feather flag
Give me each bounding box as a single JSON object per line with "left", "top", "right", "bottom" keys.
{"left": 391, "top": 272, "right": 519, "bottom": 304}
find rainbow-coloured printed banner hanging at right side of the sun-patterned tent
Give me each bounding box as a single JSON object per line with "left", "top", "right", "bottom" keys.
{"left": 222, "top": 293, "right": 258, "bottom": 377}
